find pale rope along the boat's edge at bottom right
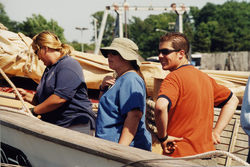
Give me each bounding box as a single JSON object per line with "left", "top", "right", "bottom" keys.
{"left": 122, "top": 150, "right": 250, "bottom": 167}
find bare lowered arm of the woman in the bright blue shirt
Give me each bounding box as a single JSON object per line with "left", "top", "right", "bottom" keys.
{"left": 119, "top": 108, "right": 143, "bottom": 146}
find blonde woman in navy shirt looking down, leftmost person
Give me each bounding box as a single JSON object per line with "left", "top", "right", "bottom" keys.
{"left": 13, "top": 31, "right": 95, "bottom": 135}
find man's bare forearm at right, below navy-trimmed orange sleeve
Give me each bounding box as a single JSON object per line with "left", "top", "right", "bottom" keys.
{"left": 212, "top": 94, "right": 239, "bottom": 144}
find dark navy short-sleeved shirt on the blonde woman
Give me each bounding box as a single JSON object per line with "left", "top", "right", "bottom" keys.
{"left": 36, "top": 55, "right": 95, "bottom": 128}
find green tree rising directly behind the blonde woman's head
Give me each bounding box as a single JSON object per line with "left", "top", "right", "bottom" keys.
{"left": 19, "top": 14, "right": 66, "bottom": 43}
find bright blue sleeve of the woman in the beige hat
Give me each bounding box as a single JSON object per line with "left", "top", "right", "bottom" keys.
{"left": 119, "top": 77, "right": 146, "bottom": 115}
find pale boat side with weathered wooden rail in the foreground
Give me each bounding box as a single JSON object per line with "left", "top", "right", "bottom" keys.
{"left": 0, "top": 110, "right": 194, "bottom": 167}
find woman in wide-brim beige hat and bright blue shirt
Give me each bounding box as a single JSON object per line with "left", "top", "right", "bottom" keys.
{"left": 96, "top": 38, "right": 151, "bottom": 151}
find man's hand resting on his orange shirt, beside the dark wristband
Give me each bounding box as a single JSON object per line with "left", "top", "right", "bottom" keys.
{"left": 161, "top": 136, "right": 183, "bottom": 154}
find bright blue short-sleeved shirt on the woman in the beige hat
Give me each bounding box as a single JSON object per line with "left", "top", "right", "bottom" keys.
{"left": 96, "top": 72, "right": 151, "bottom": 151}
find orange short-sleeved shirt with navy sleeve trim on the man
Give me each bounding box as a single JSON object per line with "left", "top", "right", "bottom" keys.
{"left": 158, "top": 65, "right": 232, "bottom": 157}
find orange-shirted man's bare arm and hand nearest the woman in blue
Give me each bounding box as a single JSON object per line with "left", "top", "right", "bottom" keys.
{"left": 155, "top": 98, "right": 182, "bottom": 153}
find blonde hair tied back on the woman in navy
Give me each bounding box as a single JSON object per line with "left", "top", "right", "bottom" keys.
{"left": 31, "top": 31, "right": 74, "bottom": 57}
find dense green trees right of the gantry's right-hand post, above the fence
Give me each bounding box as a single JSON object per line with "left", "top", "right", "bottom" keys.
{"left": 191, "top": 0, "right": 250, "bottom": 52}
